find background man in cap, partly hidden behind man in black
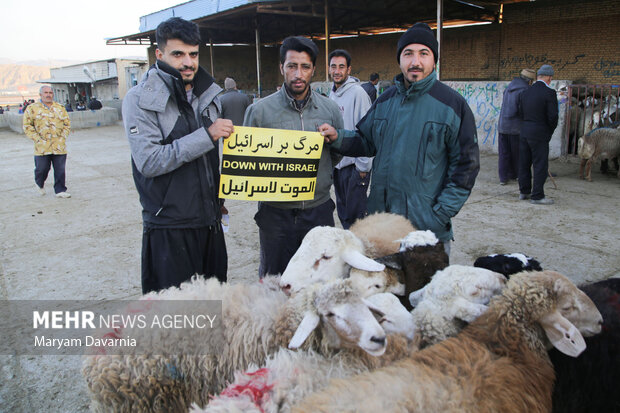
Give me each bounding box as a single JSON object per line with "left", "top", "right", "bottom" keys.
{"left": 497, "top": 69, "right": 536, "bottom": 185}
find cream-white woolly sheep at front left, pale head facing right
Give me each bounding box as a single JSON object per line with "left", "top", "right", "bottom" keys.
{"left": 82, "top": 277, "right": 386, "bottom": 412}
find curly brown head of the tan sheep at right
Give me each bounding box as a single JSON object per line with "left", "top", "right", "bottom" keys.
{"left": 502, "top": 271, "right": 603, "bottom": 357}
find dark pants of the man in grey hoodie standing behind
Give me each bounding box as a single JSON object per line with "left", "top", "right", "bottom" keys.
{"left": 334, "top": 165, "right": 370, "bottom": 229}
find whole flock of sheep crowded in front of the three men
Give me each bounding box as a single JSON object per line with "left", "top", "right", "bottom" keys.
{"left": 82, "top": 213, "right": 620, "bottom": 413}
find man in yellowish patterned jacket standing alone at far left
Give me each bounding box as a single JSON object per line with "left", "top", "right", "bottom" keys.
{"left": 23, "top": 86, "right": 71, "bottom": 198}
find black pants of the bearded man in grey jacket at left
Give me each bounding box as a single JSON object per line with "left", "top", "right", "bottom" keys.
{"left": 142, "top": 227, "right": 228, "bottom": 294}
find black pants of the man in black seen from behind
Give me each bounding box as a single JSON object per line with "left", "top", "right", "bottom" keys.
{"left": 519, "top": 136, "right": 549, "bottom": 200}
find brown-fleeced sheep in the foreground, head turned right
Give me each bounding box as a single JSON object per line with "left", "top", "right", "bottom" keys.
{"left": 292, "top": 271, "right": 602, "bottom": 413}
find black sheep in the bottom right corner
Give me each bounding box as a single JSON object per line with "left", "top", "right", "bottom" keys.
{"left": 549, "top": 278, "right": 620, "bottom": 413}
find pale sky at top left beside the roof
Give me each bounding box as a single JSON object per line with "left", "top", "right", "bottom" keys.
{"left": 0, "top": 0, "right": 186, "bottom": 61}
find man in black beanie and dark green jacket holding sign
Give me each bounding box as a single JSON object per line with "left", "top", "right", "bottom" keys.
{"left": 319, "top": 23, "right": 480, "bottom": 254}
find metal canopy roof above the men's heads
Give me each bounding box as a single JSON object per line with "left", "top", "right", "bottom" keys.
{"left": 107, "top": 0, "right": 528, "bottom": 45}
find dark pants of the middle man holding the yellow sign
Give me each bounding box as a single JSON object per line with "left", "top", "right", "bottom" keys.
{"left": 254, "top": 199, "right": 334, "bottom": 278}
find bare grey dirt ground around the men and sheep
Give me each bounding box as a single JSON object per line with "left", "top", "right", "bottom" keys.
{"left": 0, "top": 124, "right": 620, "bottom": 412}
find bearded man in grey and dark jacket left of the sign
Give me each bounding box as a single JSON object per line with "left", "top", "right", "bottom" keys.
{"left": 123, "top": 17, "right": 233, "bottom": 293}
